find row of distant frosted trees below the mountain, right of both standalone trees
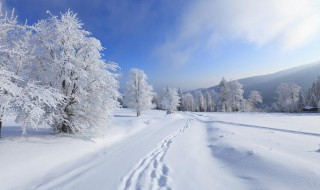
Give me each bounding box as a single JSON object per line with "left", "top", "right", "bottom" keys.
{"left": 181, "top": 77, "right": 320, "bottom": 112}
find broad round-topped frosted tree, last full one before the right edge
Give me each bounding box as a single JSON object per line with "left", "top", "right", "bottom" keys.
{"left": 277, "top": 83, "right": 301, "bottom": 112}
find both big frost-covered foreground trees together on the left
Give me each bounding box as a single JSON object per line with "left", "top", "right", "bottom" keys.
{"left": 0, "top": 6, "right": 120, "bottom": 137}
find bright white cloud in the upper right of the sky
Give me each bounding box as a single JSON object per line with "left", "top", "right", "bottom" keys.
{"left": 156, "top": 0, "right": 320, "bottom": 64}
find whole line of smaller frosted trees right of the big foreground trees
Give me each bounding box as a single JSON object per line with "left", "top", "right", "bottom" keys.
{"left": 124, "top": 69, "right": 320, "bottom": 116}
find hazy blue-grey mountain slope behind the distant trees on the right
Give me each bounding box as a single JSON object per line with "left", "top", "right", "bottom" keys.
{"left": 206, "top": 61, "right": 320, "bottom": 104}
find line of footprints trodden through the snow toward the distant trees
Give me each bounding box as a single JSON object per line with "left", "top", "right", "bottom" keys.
{"left": 119, "top": 118, "right": 192, "bottom": 190}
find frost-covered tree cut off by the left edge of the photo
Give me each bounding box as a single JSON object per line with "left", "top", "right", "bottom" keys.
{"left": 0, "top": 5, "right": 61, "bottom": 137}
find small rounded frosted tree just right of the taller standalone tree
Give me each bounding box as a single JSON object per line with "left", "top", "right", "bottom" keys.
{"left": 161, "top": 87, "right": 180, "bottom": 114}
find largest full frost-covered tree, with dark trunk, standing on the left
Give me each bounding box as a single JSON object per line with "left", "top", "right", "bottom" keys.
{"left": 31, "top": 11, "right": 119, "bottom": 133}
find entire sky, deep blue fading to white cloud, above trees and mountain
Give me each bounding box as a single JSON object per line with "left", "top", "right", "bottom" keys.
{"left": 3, "top": 0, "right": 320, "bottom": 90}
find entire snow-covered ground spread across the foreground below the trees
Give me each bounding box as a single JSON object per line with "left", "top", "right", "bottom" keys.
{"left": 0, "top": 109, "right": 320, "bottom": 190}
